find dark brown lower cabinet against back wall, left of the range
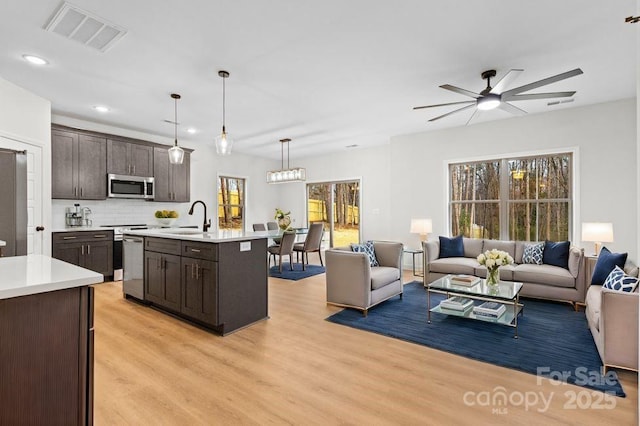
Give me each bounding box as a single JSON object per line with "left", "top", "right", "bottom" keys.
{"left": 51, "top": 230, "right": 113, "bottom": 276}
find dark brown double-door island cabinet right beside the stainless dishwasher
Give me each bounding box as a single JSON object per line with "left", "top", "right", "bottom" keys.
{"left": 144, "top": 251, "right": 181, "bottom": 312}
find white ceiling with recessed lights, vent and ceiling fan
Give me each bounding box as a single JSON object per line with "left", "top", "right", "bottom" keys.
{"left": 0, "top": 0, "right": 640, "bottom": 159}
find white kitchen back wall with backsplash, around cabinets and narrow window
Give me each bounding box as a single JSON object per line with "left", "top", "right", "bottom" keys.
{"left": 52, "top": 115, "right": 279, "bottom": 230}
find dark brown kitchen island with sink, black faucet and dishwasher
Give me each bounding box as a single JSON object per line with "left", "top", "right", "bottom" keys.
{"left": 123, "top": 228, "right": 268, "bottom": 335}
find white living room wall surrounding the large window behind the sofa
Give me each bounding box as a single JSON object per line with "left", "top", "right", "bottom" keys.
{"left": 390, "top": 99, "right": 638, "bottom": 260}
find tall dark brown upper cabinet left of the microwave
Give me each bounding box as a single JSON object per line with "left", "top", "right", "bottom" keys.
{"left": 51, "top": 129, "right": 107, "bottom": 200}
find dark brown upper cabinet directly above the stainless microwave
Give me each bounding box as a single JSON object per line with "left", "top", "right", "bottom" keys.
{"left": 107, "top": 139, "right": 153, "bottom": 177}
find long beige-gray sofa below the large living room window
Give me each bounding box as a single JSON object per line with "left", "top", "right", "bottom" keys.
{"left": 422, "top": 238, "right": 586, "bottom": 309}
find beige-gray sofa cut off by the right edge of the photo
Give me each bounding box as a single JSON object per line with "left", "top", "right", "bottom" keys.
{"left": 585, "top": 262, "right": 640, "bottom": 372}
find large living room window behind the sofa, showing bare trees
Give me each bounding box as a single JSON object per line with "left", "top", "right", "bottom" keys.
{"left": 449, "top": 153, "right": 573, "bottom": 241}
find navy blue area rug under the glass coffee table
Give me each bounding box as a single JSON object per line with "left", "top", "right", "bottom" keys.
{"left": 327, "top": 281, "right": 625, "bottom": 397}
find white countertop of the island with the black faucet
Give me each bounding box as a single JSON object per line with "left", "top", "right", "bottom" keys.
{"left": 124, "top": 228, "right": 279, "bottom": 243}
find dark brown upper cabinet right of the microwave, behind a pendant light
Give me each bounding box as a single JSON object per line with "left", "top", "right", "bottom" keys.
{"left": 153, "top": 147, "right": 191, "bottom": 203}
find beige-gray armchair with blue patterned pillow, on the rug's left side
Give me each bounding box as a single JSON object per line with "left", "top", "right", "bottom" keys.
{"left": 325, "top": 241, "right": 402, "bottom": 316}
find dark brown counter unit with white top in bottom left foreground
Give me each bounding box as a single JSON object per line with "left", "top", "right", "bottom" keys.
{"left": 0, "top": 255, "right": 103, "bottom": 425}
